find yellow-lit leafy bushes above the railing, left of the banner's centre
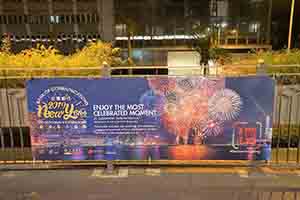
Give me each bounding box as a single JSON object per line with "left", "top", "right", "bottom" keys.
{"left": 0, "top": 39, "right": 122, "bottom": 69}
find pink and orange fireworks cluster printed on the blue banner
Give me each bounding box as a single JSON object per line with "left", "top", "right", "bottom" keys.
{"left": 149, "top": 77, "right": 232, "bottom": 142}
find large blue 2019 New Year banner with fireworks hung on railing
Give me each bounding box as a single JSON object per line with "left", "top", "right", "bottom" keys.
{"left": 27, "top": 76, "right": 274, "bottom": 160}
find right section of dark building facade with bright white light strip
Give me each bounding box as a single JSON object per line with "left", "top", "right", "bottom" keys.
{"left": 115, "top": 0, "right": 271, "bottom": 48}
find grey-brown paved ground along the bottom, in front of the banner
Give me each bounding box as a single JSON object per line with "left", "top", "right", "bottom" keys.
{"left": 0, "top": 168, "right": 300, "bottom": 200}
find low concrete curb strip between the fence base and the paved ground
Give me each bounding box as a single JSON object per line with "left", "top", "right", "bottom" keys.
{"left": 0, "top": 164, "right": 300, "bottom": 178}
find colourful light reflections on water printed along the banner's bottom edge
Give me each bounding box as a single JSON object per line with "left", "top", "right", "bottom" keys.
{"left": 33, "top": 145, "right": 268, "bottom": 160}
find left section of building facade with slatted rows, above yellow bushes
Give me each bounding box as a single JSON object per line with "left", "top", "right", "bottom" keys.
{"left": 0, "top": 0, "right": 114, "bottom": 52}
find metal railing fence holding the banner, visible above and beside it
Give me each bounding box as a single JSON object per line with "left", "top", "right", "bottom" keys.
{"left": 0, "top": 66, "right": 300, "bottom": 165}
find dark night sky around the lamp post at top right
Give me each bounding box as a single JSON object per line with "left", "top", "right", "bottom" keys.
{"left": 272, "top": 0, "right": 300, "bottom": 49}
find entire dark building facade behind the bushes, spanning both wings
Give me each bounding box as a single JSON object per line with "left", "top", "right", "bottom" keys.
{"left": 0, "top": 0, "right": 271, "bottom": 53}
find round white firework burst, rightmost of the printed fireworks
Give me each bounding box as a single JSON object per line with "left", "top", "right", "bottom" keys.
{"left": 208, "top": 89, "right": 243, "bottom": 121}
